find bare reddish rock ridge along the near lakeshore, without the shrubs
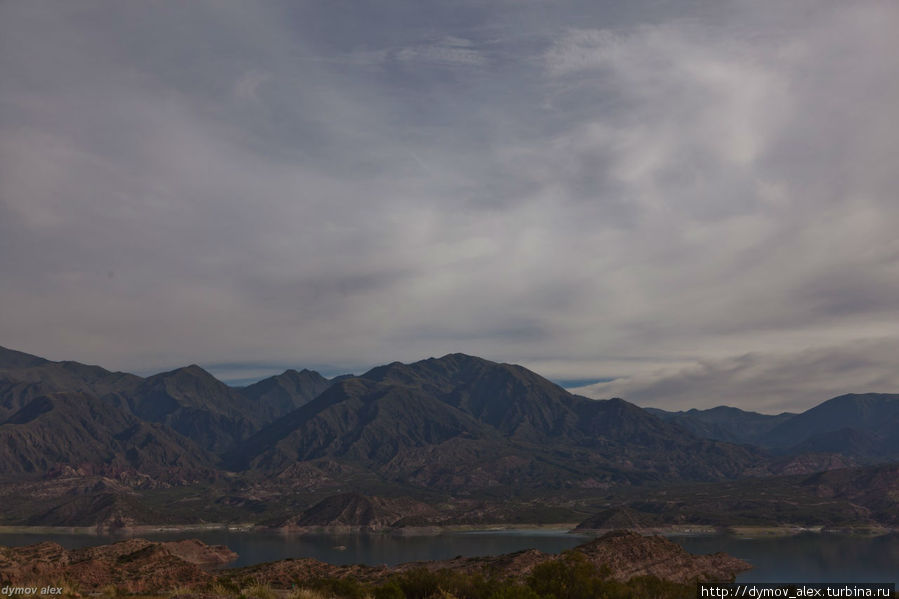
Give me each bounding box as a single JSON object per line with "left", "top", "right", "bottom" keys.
{"left": 0, "top": 531, "right": 750, "bottom": 593}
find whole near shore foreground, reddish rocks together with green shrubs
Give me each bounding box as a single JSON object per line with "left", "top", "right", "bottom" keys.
{"left": 0, "top": 532, "right": 750, "bottom": 598}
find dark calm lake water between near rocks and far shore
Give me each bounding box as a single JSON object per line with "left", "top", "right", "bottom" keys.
{"left": 0, "top": 530, "right": 899, "bottom": 585}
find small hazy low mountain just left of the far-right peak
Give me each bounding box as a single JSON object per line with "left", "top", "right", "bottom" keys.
{"left": 644, "top": 406, "right": 796, "bottom": 444}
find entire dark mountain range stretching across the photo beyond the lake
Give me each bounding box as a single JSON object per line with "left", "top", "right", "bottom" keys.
{"left": 0, "top": 348, "right": 899, "bottom": 522}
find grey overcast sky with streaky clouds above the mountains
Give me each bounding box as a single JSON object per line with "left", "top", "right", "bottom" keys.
{"left": 0, "top": 0, "right": 899, "bottom": 412}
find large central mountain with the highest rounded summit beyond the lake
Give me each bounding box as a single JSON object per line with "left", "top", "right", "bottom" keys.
{"left": 226, "top": 354, "right": 761, "bottom": 489}
